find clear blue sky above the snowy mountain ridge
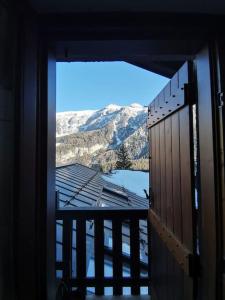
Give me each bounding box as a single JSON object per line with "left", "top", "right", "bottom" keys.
{"left": 56, "top": 62, "right": 168, "bottom": 112}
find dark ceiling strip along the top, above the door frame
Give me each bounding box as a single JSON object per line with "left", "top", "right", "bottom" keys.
{"left": 28, "top": 0, "right": 225, "bottom": 14}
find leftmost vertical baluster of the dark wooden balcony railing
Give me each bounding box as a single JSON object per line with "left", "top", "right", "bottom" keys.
{"left": 63, "top": 218, "right": 73, "bottom": 290}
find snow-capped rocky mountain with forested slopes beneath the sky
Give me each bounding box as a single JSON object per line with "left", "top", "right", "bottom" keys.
{"left": 56, "top": 103, "right": 148, "bottom": 165}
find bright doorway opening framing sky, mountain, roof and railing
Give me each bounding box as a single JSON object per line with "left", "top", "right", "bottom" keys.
{"left": 56, "top": 61, "right": 168, "bottom": 295}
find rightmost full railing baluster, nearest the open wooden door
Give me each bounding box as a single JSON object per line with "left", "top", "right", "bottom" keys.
{"left": 130, "top": 218, "right": 140, "bottom": 295}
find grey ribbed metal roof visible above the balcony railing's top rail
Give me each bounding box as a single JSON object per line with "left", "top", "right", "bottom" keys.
{"left": 56, "top": 163, "right": 148, "bottom": 208}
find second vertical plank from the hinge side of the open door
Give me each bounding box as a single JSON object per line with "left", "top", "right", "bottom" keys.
{"left": 171, "top": 113, "right": 182, "bottom": 241}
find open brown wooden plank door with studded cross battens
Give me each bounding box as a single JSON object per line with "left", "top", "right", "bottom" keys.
{"left": 148, "top": 62, "right": 196, "bottom": 300}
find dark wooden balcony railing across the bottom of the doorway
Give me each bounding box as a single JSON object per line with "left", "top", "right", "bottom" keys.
{"left": 56, "top": 207, "right": 150, "bottom": 295}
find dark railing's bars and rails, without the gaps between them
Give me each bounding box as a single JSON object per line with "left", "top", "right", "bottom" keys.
{"left": 57, "top": 209, "right": 150, "bottom": 297}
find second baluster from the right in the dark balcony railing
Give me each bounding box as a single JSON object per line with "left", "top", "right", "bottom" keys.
{"left": 112, "top": 219, "right": 123, "bottom": 295}
